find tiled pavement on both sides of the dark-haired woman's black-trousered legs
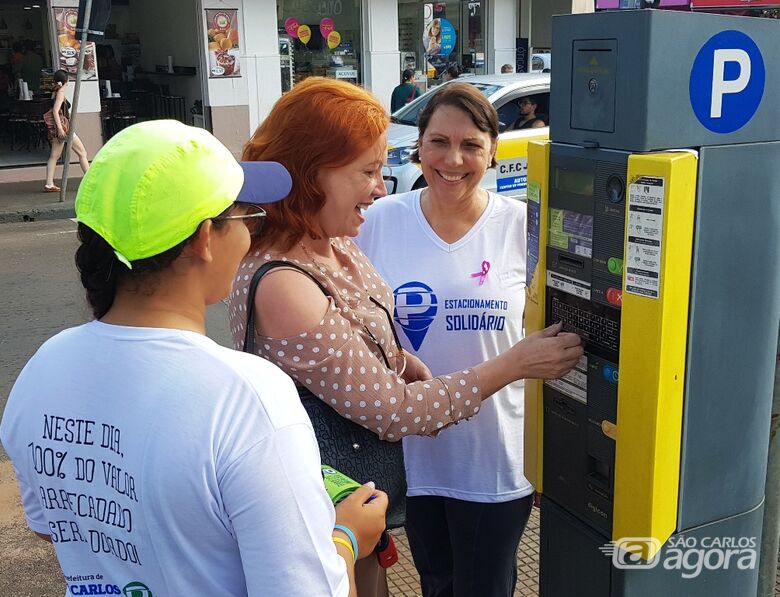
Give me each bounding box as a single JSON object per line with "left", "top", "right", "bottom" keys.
{"left": 387, "top": 508, "right": 539, "bottom": 597}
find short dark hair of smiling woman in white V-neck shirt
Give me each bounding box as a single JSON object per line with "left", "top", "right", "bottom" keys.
{"left": 411, "top": 83, "right": 498, "bottom": 168}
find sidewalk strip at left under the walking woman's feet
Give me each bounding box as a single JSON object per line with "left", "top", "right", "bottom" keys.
{"left": 0, "top": 178, "right": 81, "bottom": 224}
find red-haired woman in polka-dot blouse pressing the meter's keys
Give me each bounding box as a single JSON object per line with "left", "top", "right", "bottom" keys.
{"left": 230, "top": 77, "right": 582, "bottom": 597}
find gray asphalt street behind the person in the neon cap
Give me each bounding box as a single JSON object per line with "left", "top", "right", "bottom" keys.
{"left": 0, "top": 220, "right": 230, "bottom": 597}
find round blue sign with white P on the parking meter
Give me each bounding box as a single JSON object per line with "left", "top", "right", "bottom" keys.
{"left": 688, "top": 30, "right": 766, "bottom": 133}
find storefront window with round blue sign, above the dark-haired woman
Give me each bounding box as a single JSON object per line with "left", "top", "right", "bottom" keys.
{"left": 398, "top": 0, "right": 486, "bottom": 91}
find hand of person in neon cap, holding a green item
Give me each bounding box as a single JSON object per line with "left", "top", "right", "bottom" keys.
{"left": 333, "top": 482, "right": 388, "bottom": 560}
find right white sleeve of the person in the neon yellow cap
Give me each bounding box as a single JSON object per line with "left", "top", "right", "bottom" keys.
{"left": 220, "top": 424, "right": 349, "bottom": 597}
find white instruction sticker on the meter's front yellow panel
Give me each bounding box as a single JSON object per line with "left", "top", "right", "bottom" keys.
{"left": 626, "top": 176, "right": 664, "bottom": 298}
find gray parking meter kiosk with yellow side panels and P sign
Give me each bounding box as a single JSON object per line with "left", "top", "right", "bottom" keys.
{"left": 526, "top": 10, "right": 780, "bottom": 597}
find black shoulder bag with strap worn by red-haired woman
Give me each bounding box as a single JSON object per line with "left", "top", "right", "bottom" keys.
{"left": 243, "top": 261, "right": 406, "bottom": 529}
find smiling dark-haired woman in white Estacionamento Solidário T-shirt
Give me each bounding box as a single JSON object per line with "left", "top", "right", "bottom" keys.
{"left": 357, "top": 83, "right": 552, "bottom": 597}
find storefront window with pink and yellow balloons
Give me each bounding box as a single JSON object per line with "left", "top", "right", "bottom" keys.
{"left": 276, "top": 0, "right": 363, "bottom": 92}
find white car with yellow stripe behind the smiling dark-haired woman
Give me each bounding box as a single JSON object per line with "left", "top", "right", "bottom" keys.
{"left": 384, "top": 73, "right": 550, "bottom": 197}
